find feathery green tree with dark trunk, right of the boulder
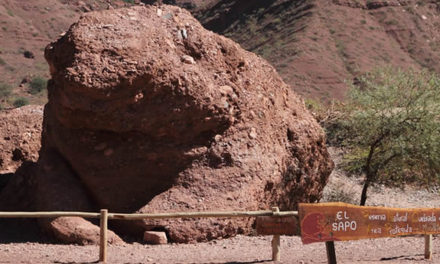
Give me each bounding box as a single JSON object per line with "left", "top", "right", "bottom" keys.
{"left": 331, "top": 68, "right": 440, "bottom": 205}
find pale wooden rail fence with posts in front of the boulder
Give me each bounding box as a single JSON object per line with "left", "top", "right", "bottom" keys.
{"left": 0, "top": 207, "right": 298, "bottom": 263}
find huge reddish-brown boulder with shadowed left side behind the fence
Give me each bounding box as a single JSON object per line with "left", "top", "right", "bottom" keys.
{"left": 36, "top": 5, "right": 333, "bottom": 242}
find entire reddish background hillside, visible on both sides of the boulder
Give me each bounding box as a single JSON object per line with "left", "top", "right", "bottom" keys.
{"left": 0, "top": 0, "right": 440, "bottom": 106}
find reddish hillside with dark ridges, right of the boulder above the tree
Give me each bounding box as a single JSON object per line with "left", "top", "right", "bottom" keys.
{"left": 167, "top": 0, "right": 440, "bottom": 101}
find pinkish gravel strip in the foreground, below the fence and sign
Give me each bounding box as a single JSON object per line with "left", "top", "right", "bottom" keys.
{"left": 0, "top": 236, "right": 440, "bottom": 264}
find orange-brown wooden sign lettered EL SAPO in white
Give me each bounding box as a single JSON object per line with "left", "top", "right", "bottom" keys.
{"left": 299, "top": 203, "right": 440, "bottom": 244}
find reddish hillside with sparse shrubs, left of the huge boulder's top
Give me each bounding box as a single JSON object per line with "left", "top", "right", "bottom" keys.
{"left": 0, "top": 0, "right": 129, "bottom": 108}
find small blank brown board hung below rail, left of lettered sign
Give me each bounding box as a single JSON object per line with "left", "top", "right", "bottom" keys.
{"left": 257, "top": 216, "right": 299, "bottom": 236}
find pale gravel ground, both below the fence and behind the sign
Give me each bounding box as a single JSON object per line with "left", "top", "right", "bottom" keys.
{"left": 0, "top": 147, "right": 440, "bottom": 264}
